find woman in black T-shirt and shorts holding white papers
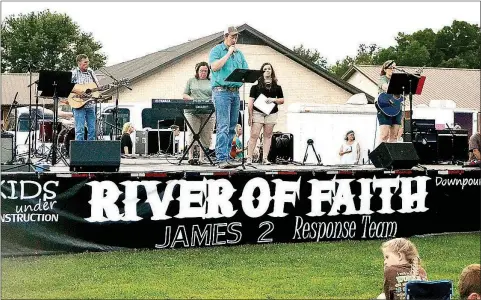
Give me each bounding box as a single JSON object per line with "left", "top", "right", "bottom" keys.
{"left": 247, "top": 63, "right": 284, "bottom": 165}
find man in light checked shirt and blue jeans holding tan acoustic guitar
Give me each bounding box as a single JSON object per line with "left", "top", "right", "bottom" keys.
{"left": 72, "top": 54, "right": 99, "bottom": 141}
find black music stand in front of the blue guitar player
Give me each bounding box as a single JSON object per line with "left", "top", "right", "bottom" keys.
{"left": 386, "top": 72, "right": 426, "bottom": 142}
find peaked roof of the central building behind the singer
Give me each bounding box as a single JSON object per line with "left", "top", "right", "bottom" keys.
{"left": 100, "top": 24, "right": 374, "bottom": 102}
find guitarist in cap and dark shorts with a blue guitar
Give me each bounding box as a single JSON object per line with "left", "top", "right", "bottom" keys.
{"left": 376, "top": 60, "right": 403, "bottom": 143}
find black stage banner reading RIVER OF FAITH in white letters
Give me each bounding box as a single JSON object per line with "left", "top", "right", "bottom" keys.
{"left": 1, "top": 170, "right": 481, "bottom": 255}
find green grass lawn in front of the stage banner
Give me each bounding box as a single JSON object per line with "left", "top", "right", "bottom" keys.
{"left": 2, "top": 233, "right": 480, "bottom": 299}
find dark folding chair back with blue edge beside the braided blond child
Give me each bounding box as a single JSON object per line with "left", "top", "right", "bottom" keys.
{"left": 405, "top": 280, "right": 453, "bottom": 300}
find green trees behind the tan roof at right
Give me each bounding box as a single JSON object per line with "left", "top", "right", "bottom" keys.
{"left": 314, "top": 20, "right": 481, "bottom": 77}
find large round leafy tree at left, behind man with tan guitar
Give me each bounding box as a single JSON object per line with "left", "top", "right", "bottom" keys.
{"left": 1, "top": 10, "right": 107, "bottom": 73}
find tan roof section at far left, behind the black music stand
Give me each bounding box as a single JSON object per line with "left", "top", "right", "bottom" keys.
{"left": 2, "top": 73, "right": 39, "bottom": 105}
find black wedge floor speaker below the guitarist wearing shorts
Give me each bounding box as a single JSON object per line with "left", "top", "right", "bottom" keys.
{"left": 369, "top": 143, "right": 419, "bottom": 169}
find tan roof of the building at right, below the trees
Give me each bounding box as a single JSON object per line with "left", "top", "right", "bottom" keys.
{"left": 342, "top": 65, "right": 481, "bottom": 111}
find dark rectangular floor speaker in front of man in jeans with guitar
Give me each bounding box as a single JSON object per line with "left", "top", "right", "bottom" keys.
{"left": 70, "top": 141, "right": 120, "bottom": 172}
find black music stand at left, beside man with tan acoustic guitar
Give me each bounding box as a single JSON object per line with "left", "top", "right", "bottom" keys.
{"left": 38, "top": 70, "right": 75, "bottom": 166}
